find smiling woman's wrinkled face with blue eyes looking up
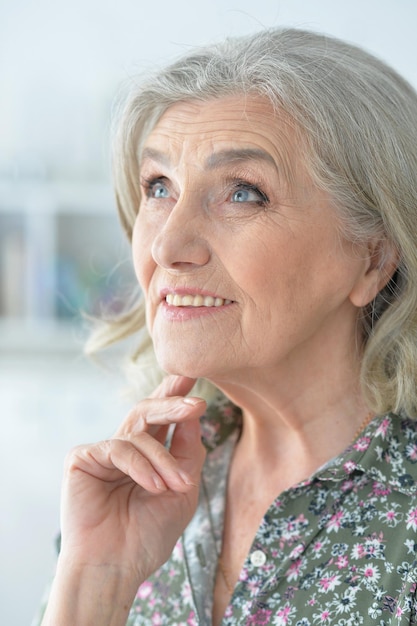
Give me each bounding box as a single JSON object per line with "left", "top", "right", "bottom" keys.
{"left": 133, "top": 97, "right": 365, "bottom": 382}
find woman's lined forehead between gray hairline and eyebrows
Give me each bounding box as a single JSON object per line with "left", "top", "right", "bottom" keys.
{"left": 141, "top": 96, "right": 297, "bottom": 169}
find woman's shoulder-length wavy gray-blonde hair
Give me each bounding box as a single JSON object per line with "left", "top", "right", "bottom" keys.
{"left": 89, "top": 29, "right": 417, "bottom": 415}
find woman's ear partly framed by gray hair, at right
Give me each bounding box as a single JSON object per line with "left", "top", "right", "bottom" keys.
{"left": 350, "top": 239, "right": 400, "bottom": 307}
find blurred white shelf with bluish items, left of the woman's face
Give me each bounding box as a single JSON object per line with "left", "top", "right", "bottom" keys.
{"left": 0, "top": 180, "right": 136, "bottom": 334}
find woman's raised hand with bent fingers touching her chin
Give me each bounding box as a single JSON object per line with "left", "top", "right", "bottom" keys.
{"left": 57, "top": 376, "right": 205, "bottom": 585}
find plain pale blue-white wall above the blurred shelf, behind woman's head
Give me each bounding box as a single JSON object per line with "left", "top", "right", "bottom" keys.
{"left": 0, "top": 0, "right": 417, "bottom": 178}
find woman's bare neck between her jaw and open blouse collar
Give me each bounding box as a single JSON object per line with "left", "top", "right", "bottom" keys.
{"left": 210, "top": 344, "right": 369, "bottom": 469}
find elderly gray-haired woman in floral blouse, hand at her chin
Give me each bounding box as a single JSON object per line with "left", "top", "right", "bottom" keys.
{"left": 42, "top": 30, "right": 417, "bottom": 626}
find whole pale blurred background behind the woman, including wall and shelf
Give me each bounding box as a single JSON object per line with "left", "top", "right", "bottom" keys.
{"left": 0, "top": 0, "right": 417, "bottom": 626}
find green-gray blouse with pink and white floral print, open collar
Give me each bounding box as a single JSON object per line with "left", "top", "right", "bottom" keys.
{"left": 126, "top": 398, "right": 417, "bottom": 626}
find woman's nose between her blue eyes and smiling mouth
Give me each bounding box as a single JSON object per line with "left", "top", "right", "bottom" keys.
{"left": 152, "top": 200, "right": 210, "bottom": 270}
